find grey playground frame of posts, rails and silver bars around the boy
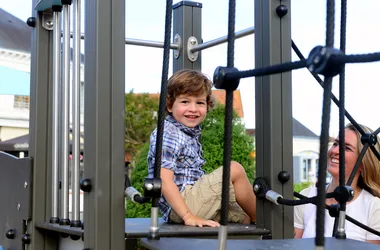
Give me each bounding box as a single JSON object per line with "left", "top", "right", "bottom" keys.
{"left": 0, "top": 0, "right": 378, "bottom": 250}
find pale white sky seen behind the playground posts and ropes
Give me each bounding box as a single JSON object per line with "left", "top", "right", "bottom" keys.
{"left": 0, "top": 0, "right": 380, "bottom": 136}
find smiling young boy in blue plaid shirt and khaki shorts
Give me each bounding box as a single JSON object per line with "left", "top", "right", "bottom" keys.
{"left": 148, "top": 70, "right": 256, "bottom": 227}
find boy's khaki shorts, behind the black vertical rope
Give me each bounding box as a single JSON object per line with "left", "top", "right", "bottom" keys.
{"left": 169, "top": 167, "right": 246, "bottom": 223}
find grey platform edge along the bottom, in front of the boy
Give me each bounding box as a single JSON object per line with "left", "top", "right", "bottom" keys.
{"left": 140, "top": 238, "right": 380, "bottom": 250}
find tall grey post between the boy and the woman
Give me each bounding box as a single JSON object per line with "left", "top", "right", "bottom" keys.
{"left": 255, "top": 0, "right": 294, "bottom": 239}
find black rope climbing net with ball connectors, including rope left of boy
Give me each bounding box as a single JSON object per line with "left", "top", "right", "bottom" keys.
{"left": 131, "top": 0, "right": 380, "bottom": 247}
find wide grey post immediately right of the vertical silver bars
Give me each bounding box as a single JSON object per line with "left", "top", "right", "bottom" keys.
{"left": 84, "top": 0, "right": 125, "bottom": 250}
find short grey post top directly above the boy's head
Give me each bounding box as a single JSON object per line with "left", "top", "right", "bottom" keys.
{"left": 173, "top": 1, "right": 202, "bottom": 72}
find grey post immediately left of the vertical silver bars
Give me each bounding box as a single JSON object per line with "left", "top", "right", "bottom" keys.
{"left": 28, "top": 0, "right": 57, "bottom": 250}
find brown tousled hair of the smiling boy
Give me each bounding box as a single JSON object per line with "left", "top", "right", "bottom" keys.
{"left": 166, "top": 69, "right": 215, "bottom": 111}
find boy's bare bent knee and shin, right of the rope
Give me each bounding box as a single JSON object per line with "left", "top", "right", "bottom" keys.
{"left": 231, "top": 161, "right": 256, "bottom": 221}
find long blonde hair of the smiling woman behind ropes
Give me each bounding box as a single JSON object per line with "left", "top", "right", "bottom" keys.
{"left": 346, "top": 124, "right": 380, "bottom": 197}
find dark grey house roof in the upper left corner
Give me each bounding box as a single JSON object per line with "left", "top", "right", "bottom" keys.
{"left": 0, "top": 8, "right": 32, "bottom": 52}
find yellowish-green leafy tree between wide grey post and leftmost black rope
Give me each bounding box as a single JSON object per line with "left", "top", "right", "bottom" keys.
{"left": 125, "top": 90, "right": 158, "bottom": 158}
